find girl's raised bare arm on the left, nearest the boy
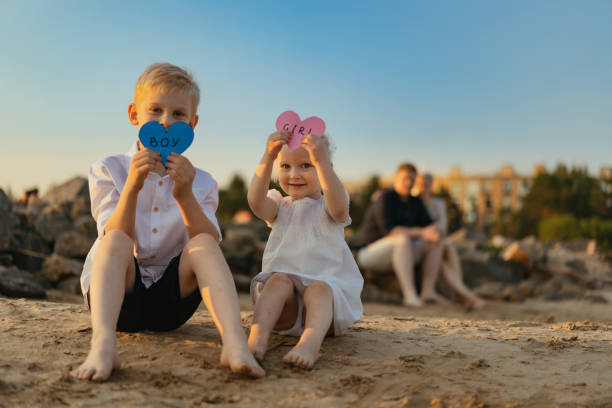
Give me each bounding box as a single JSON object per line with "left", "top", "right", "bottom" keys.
{"left": 247, "top": 131, "right": 289, "bottom": 223}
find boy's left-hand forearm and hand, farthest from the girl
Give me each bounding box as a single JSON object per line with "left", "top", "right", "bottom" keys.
{"left": 104, "top": 149, "right": 161, "bottom": 240}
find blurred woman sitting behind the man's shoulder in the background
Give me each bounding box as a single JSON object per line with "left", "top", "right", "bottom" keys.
{"left": 414, "top": 173, "right": 485, "bottom": 309}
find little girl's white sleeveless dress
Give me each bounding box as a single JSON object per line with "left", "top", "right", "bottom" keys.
{"left": 251, "top": 190, "right": 363, "bottom": 336}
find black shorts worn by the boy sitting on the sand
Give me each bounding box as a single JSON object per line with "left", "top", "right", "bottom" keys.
{"left": 88, "top": 254, "right": 202, "bottom": 332}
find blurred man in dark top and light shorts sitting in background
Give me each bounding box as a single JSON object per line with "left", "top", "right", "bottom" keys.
{"left": 357, "top": 163, "right": 447, "bottom": 307}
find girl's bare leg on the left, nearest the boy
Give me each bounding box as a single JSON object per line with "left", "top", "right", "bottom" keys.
{"left": 249, "top": 273, "right": 298, "bottom": 360}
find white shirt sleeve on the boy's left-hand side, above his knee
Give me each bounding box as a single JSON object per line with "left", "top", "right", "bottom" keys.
{"left": 88, "top": 162, "right": 121, "bottom": 238}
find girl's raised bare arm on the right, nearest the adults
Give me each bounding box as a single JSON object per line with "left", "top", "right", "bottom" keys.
{"left": 302, "top": 135, "right": 349, "bottom": 222}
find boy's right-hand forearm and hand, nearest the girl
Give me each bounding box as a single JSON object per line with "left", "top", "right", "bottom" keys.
{"left": 166, "top": 153, "right": 219, "bottom": 241}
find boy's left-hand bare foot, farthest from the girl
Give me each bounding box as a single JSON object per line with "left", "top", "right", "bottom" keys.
{"left": 70, "top": 333, "right": 121, "bottom": 381}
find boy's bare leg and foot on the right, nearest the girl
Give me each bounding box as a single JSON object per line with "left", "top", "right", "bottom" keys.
{"left": 179, "top": 234, "right": 266, "bottom": 377}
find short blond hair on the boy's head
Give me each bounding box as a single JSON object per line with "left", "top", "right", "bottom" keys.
{"left": 134, "top": 62, "right": 200, "bottom": 115}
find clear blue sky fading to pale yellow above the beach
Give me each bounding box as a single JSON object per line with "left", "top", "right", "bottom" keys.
{"left": 0, "top": 0, "right": 612, "bottom": 194}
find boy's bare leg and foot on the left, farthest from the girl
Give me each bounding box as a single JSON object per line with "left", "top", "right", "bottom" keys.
{"left": 72, "top": 230, "right": 136, "bottom": 381}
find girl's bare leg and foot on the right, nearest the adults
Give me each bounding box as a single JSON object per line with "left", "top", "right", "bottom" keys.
{"left": 283, "top": 281, "right": 334, "bottom": 368}
